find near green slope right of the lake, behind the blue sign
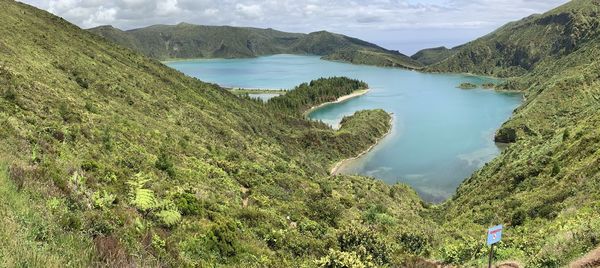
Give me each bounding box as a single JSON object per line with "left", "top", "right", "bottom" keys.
{"left": 426, "top": 0, "right": 600, "bottom": 267}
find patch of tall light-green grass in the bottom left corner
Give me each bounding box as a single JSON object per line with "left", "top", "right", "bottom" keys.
{"left": 0, "top": 163, "right": 96, "bottom": 268}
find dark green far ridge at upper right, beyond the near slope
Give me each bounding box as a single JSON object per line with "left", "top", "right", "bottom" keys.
{"left": 428, "top": 0, "right": 600, "bottom": 77}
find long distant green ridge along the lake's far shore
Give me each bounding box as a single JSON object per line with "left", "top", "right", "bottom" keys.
{"left": 88, "top": 23, "right": 422, "bottom": 69}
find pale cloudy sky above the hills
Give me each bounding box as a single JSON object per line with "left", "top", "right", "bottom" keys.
{"left": 23, "top": 0, "right": 568, "bottom": 54}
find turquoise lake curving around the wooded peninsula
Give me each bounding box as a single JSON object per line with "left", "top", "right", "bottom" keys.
{"left": 166, "top": 55, "right": 522, "bottom": 202}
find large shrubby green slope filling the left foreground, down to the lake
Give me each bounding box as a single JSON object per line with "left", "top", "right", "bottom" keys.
{"left": 0, "top": 0, "right": 434, "bottom": 267}
